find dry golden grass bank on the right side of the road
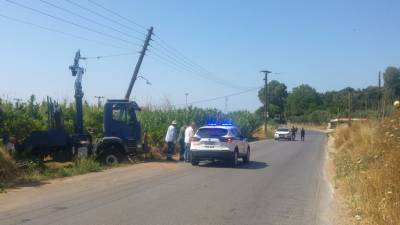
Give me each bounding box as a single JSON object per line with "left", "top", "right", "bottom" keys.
{"left": 333, "top": 112, "right": 400, "bottom": 225}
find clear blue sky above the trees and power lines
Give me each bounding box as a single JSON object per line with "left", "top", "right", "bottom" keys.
{"left": 0, "top": 0, "right": 400, "bottom": 111}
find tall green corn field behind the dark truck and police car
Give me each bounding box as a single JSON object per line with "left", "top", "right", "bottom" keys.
{"left": 0, "top": 96, "right": 262, "bottom": 147}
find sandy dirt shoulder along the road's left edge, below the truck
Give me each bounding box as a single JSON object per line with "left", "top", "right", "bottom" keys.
{"left": 0, "top": 162, "right": 184, "bottom": 213}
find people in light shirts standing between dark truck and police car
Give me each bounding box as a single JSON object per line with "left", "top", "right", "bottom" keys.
{"left": 165, "top": 120, "right": 196, "bottom": 162}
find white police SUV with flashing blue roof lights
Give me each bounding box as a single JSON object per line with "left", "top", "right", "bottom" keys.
{"left": 190, "top": 124, "right": 250, "bottom": 167}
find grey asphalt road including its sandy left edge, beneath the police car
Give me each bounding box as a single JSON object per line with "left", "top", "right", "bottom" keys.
{"left": 0, "top": 132, "right": 329, "bottom": 225}
